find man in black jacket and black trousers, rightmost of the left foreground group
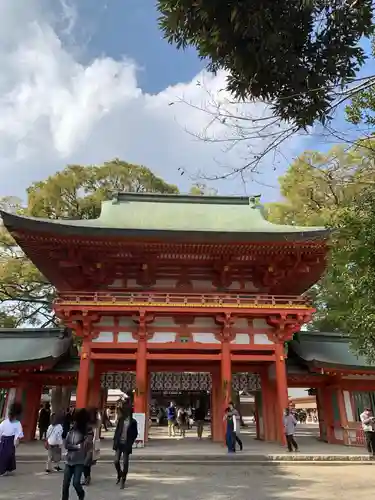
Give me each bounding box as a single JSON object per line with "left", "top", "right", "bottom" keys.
{"left": 113, "top": 405, "right": 138, "bottom": 489}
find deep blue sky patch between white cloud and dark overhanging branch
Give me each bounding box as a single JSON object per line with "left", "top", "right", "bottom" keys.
{"left": 72, "top": 0, "right": 204, "bottom": 93}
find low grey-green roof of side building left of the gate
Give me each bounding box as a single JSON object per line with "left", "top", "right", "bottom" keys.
{"left": 0, "top": 328, "right": 72, "bottom": 367}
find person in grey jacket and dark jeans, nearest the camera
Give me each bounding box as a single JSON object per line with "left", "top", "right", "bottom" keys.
{"left": 61, "top": 409, "right": 90, "bottom": 500}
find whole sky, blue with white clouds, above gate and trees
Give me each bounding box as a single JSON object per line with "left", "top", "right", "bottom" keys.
{"left": 0, "top": 0, "right": 375, "bottom": 205}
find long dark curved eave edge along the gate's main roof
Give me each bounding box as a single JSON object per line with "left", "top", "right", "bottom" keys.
{"left": 0, "top": 211, "right": 331, "bottom": 244}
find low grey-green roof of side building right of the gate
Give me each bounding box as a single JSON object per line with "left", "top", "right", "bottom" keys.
{"left": 289, "top": 332, "right": 375, "bottom": 370}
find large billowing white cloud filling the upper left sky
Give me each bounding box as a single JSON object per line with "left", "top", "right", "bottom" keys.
{"left": 0, "top": 0, "right": 304, "bottom": 196}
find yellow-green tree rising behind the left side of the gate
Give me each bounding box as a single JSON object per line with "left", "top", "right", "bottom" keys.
{"left": 0, "top": 159, "right": 178, "bottom": 327}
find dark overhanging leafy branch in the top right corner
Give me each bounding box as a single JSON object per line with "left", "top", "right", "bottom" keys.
{"left": 158, "top": 0, "right": 373, "bottom": 128}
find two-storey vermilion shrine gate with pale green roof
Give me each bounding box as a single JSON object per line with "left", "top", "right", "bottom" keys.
{"left": 1, "top": 193, "right": 329, "bottom": 442}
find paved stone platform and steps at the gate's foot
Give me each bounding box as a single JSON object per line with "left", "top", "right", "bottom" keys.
{"left": 17, "top": 424, "right": 368, "bottom": 462}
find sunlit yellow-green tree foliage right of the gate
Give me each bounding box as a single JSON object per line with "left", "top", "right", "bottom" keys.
{"left": 267, "top": 141, "right": 375, "bottom": 359}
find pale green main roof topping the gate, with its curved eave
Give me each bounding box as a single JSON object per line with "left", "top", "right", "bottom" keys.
{"left": 1, "top": 193, "right": 329, "bottom": 240}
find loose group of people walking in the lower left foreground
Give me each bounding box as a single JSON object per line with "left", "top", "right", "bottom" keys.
{"left": 0, "top": 403, "right": 138, "bottom": 500}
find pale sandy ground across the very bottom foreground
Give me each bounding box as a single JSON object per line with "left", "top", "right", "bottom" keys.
{"left": 0, "top": 462, "right": 375, "bottom": 500}
